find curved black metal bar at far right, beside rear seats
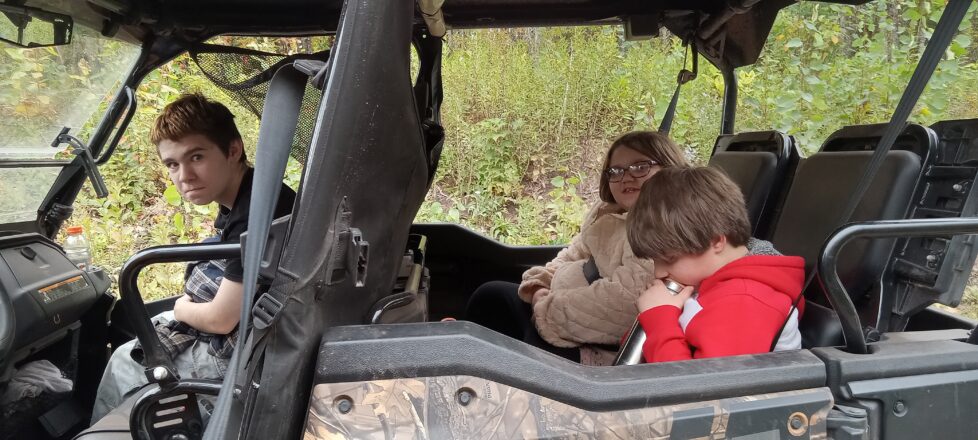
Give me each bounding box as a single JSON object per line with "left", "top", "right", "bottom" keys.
{"left": 817, "top": 217, "right": 978, "bottom": 354}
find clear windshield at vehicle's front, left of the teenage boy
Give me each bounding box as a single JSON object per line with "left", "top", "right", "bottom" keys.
{"left": 0, "top": 20, "right": 139, "bottom": 224}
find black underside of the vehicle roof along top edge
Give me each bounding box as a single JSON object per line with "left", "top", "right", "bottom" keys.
{"left": 27, "top": 0, "right": 868, "bottom": 67}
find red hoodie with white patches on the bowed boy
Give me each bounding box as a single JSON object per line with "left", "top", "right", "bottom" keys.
{"left": 638, "top": 255, "right": 805, "bottom": 362}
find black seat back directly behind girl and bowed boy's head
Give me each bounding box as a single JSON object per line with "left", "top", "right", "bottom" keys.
{"left": 709, "top": 131, "right": 799, "bottom": 239}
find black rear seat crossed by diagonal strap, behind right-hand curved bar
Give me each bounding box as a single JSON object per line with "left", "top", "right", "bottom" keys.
{"left": 772, "top": 125, "right": 936, "bottom": 346}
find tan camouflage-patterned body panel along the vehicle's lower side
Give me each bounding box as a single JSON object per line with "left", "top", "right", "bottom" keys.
{"left": 304, "top": 376, "right": 833, "bottom": 440}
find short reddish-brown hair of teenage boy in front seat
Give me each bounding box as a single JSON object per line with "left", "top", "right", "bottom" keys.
{"left": 149, "top": 93, "right": 248, "bottom": 162}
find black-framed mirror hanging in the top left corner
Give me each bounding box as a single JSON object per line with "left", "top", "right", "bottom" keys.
{"left": 0, "top": 4, "right": 74, "bottom": 48}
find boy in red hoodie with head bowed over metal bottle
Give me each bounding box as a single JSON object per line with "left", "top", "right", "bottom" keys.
{"left": 627, "top": 167, "right": 805, "bottom": 362}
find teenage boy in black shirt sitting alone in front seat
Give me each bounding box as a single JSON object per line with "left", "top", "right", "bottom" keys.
{"left": 92, "top": 94, "right": 295, "bottom": 423}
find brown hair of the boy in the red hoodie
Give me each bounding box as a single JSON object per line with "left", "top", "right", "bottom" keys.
{"left": 626, "top": 167, "right": 750, "bottom": 263}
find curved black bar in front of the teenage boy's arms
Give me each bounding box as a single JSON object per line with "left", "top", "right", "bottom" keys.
{"left": 119, "top": 243, "right": 241, "bottom": 382}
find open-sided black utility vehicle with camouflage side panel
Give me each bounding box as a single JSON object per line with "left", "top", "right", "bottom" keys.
{"left": 0, "top": 0, "right": 978, "bottom": 440}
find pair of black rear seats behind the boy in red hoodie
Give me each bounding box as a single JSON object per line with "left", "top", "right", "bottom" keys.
{"left": 709, "top": 124, "right": 937, "bottom": 347}
